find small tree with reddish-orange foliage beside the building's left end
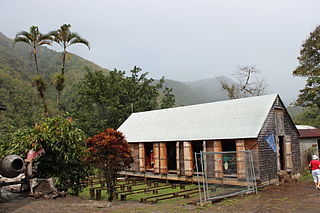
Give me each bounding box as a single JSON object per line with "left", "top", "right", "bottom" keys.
{"left": 86, "top": 129, "right": 133, "bottom": 201}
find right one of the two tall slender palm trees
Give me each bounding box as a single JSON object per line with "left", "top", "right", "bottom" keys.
{"left": 49, "top": 24, "right": 90, "bottom": 110}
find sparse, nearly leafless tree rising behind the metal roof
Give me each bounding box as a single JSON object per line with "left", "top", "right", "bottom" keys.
{"left": 220, "top": 66, "right": 268, "bottom": 99}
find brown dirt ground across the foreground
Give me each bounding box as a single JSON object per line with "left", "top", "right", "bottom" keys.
{"left": 0, "top": 181, "right": 320, "bottom": 213}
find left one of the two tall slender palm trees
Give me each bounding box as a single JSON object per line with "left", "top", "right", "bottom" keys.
{"left": 13, "top": 26, "right": 52, "bottom": 114}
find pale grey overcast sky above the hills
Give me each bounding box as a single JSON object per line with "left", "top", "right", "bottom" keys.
{"left": 0, "top": 0, "right": 320, "bottom": 101}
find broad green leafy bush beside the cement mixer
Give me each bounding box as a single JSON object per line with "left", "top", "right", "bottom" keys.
{"left": 0, "top": 115, "right": 87, "bottom": 194}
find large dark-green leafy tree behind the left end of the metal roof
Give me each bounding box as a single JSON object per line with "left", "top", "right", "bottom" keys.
{"left": 68, "top": 67, "right": 174, "bottom": 136}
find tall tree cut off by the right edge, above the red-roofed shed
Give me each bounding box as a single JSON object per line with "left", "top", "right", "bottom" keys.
{"left": 293, "top": 26, "right": 320, "bottom": 109}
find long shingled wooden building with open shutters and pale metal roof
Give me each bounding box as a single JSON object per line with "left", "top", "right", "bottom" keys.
{"left": 118, "top": 94, "right": 300, "bottom": 184}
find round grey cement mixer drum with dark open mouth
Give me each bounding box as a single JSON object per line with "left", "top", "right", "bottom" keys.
{"left": 0, "top": 155, "right": 24, "bottom": 178}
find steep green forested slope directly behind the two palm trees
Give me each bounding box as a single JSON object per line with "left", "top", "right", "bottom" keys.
{"left": 0, "top": 33, "right": 107, "bottom": 129}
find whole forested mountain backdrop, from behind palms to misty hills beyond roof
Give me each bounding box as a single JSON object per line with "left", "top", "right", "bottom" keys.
{"left": 0, "top": 30, "right": 312, "bottom": 131}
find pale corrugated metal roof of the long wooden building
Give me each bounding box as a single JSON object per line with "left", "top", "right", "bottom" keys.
{"left": 118, "top": 94, "right": 277, "bottom": 142}
